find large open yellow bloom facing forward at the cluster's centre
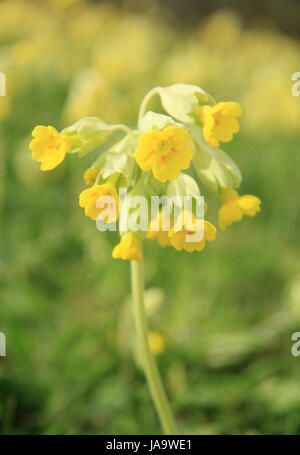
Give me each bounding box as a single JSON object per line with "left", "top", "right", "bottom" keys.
{"left": 135, "top": 126, "right": 193, "bottom": 182}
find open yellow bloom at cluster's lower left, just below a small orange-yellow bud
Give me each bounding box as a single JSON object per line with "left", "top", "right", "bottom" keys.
{"left": 79, "top": 183, "right": 120, "bottom": 223}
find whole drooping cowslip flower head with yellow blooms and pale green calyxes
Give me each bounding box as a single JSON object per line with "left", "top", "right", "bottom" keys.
{"left": 29, "top": 84, "right": 261, "bottom": 261}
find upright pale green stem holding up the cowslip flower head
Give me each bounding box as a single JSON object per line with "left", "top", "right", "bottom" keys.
{"left": 131, "top": 261, "right": 176, "bottom": 435}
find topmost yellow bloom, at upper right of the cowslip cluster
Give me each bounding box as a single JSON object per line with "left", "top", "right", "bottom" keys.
{"left": 199, "top": 102, "right": 242, "bottom": 147}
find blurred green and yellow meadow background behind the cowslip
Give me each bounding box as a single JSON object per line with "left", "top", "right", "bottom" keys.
{"left": 0, "top": 0, "right": 300, "bottom": 434}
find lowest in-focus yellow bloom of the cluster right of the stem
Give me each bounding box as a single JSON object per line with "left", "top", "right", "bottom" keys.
{"left": 169, "top": 213, "right": 217, "bottom": 253}
